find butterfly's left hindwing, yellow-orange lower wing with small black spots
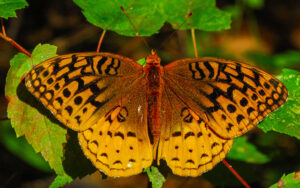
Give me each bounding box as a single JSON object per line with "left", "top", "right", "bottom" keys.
{"left": 78, "top": 81, "right": 153, "bottom": 176}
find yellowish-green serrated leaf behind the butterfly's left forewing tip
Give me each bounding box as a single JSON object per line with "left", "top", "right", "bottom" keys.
{"left": 5, "top": 44, "right": 70, "bottom": 176}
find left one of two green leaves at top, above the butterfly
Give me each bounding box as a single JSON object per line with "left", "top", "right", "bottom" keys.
{"left": 73, "top": 0, "right": 165, "bottom": 36}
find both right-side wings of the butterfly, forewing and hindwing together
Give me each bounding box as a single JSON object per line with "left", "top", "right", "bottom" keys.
{"left": 158, "top": 58, "right": 288, "bottom": 176}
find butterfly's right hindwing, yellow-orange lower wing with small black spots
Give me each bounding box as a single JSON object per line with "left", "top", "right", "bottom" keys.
{"left": 158, "top": 86, "right": 233, "bottom": 177}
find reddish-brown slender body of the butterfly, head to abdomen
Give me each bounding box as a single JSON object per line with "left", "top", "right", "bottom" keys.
{"left": 144, "top": 50, "right": 163, "bottom": 142}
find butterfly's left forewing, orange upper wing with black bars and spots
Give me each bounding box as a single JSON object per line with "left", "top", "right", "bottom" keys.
{"left": 25, "top": 53, "right": 143, "bottom": 131}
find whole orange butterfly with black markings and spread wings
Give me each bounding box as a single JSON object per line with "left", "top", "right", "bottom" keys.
{"left": 25, "top": 51, "right": 288, "bottom": 176}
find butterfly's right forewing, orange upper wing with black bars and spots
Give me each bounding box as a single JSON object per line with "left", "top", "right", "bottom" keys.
{"left": 163, "top": 57, "right": 288, "bottom": 139}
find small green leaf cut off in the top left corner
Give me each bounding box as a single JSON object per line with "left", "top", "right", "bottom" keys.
{"left": 0, "top": 0, "right": 28, "bottom": 19}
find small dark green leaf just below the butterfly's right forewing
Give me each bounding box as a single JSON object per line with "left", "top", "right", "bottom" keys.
{"left": 227, "top": 136, "right": 270, "bottom": 164}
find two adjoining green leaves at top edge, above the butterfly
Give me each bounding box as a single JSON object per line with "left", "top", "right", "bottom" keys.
{"left": 74, "top": 0, "right": 231, "bottom": 36}
